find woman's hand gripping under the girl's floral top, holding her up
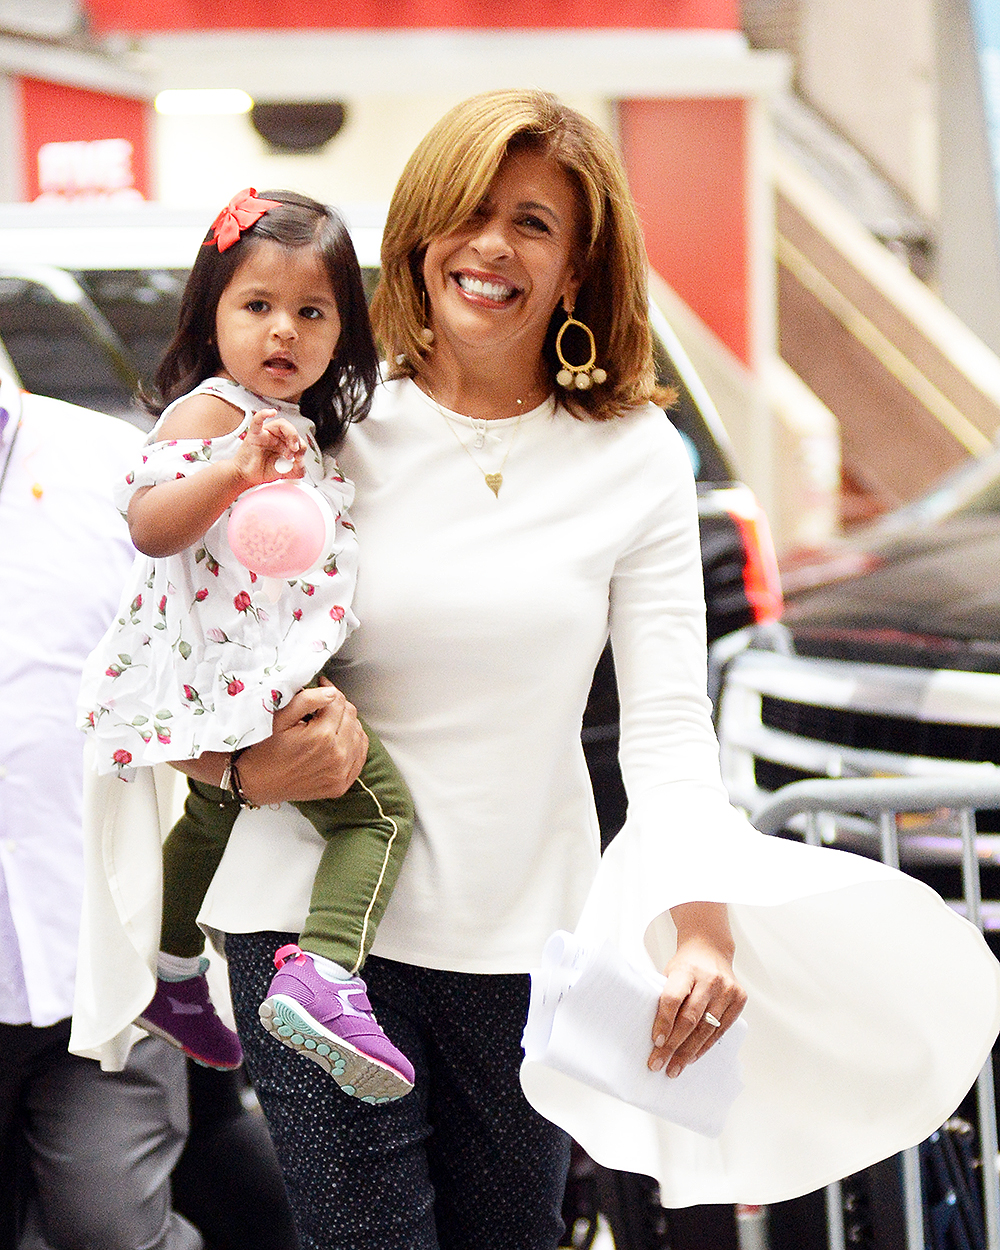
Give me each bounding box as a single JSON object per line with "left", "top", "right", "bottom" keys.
{"left": 231, "top": 678, "right": 368, "bottom": 806}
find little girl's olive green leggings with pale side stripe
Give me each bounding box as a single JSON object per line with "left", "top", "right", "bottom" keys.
{"left": 160, "top": 725, "right": 414, "bottom": 973}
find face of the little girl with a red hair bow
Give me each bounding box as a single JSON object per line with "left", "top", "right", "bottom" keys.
{"left": 215, "top": 239, "right": 340, "bottom": 404}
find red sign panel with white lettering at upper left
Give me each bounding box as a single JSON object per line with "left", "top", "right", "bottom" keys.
{"left": 20, "top": 79, "right": 153, "bottom": 200}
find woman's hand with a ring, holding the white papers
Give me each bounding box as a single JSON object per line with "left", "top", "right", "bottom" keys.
{"left": 649, "top": 903, "right": 746, "bottom": 1076}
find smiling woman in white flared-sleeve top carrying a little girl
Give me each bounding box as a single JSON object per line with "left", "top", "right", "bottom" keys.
{"left": 74, "top": 91, "right": 1000, "bottom": 1250}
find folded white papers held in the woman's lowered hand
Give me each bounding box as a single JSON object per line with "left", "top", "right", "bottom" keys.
{"left": 521, "top": 931, "right": 746, "bottom": 1138}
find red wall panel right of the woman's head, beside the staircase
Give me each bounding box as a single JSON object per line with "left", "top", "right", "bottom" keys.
{"left": 619, "top": 99, "right": 750, "bottom": 364}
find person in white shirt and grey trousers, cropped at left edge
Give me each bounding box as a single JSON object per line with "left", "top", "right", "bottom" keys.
{"left": 0, "top": 374, "right": 201, "bottom": 1250}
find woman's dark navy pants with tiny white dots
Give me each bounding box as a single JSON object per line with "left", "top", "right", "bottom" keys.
{"left": 226, "top": 933, "right": 569, "bottom": 1250}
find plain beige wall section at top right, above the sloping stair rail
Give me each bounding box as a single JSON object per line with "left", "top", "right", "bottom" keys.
{"left": 798, "top": 0, "right": 939, "bottom": 219}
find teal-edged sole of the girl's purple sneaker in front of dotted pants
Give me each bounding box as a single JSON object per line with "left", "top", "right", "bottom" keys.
{"left": 258, "top": 994, "right": 413, "bottom": 1103}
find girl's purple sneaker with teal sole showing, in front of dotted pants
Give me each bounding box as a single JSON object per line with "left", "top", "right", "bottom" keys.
{"left": 260, "top": 944, "right": 414, "bottom": 1103}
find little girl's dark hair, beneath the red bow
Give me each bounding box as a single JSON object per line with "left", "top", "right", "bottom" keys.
{"left": 143, "top": 191, "right": 379, "bottom": 449}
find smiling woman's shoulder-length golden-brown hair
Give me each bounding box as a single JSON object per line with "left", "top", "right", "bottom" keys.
{"left": 371, "top": 90, "right": 674, "bottom": 421}
